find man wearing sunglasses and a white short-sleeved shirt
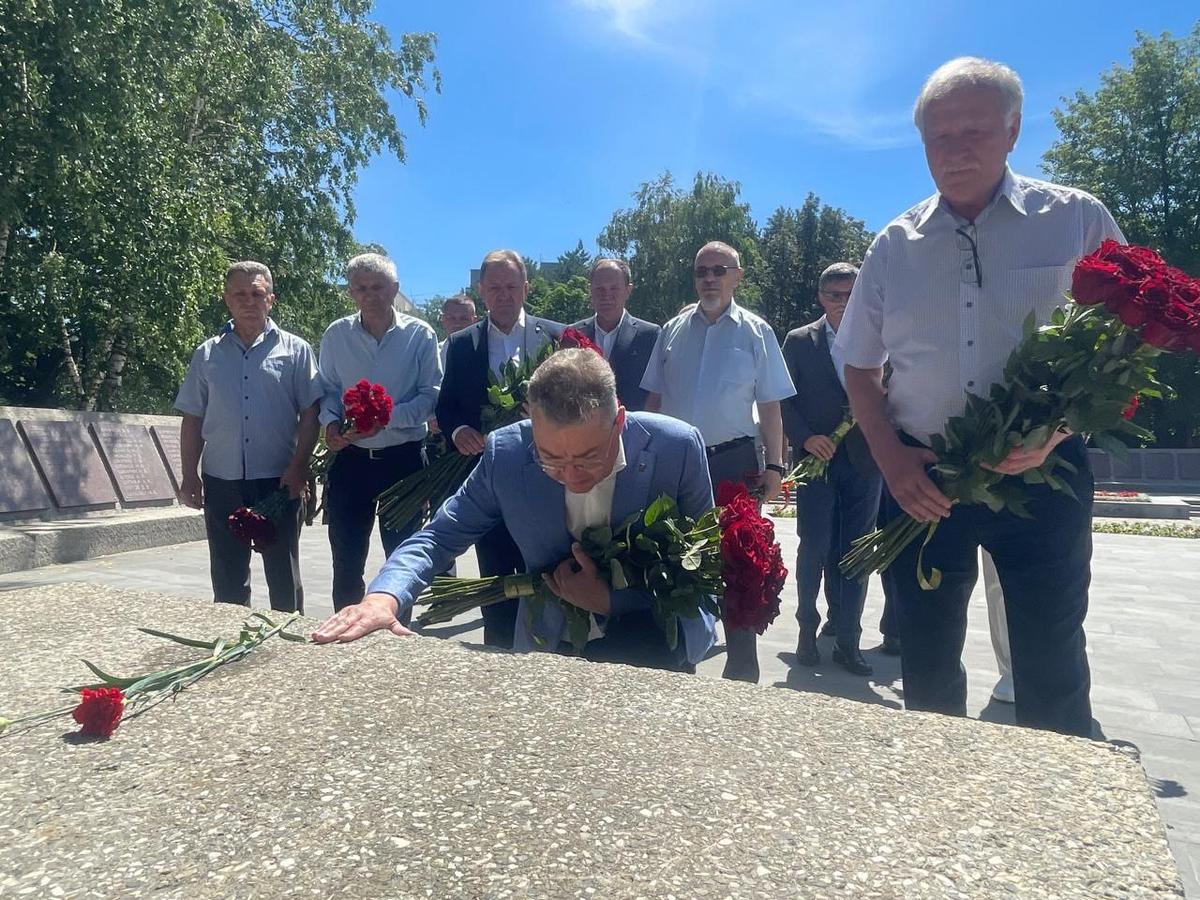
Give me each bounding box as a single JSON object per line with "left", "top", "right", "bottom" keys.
{"left": 642, "top": 241, "right": 796, "bottom": 682}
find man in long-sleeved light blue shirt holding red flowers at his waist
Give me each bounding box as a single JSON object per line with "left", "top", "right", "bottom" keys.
{"left": 320, "top": 253, "right": 442, "bottom": 610}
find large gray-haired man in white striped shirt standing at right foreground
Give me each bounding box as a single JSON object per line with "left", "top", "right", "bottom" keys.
{"left": 838, "top": 58, "right": 1122, "bottom": 736}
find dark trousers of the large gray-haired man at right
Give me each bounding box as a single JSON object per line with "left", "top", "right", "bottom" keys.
{"left": 889, "top": 437, "right": 1093, "bottom": 737}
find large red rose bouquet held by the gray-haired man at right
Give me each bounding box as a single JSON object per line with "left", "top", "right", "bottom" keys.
{"left": 841, "top": 240, "right": 1200, "bottom": 590}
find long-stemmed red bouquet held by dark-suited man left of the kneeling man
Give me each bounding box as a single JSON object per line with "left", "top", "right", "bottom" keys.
{"left": 378, "top": 328, "right": 602, "bottom": 530}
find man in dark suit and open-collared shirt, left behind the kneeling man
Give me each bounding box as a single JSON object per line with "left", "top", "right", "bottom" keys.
{"left": 434, "top": 250, "right": 563, "bottom": 648}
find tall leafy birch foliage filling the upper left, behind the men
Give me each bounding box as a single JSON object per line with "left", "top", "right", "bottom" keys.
{"left": 0, "top": 0, "right": 440, "bottom": 409}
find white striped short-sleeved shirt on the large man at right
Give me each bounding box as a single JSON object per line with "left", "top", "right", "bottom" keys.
{"left": 835, "top": 170, "right": 1123, "bottom": 440}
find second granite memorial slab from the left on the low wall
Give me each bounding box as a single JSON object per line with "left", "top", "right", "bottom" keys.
{"left": 19, "top": 421, "right": 116, "bottom": 508}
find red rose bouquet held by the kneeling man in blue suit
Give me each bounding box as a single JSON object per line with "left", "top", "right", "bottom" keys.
{"left": 418, "top": 482, "right": 787, "bottom": 652}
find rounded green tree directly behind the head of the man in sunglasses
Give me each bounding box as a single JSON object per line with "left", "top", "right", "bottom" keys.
{"left": 596, "top": 172, "right": 761, "bottom": 322}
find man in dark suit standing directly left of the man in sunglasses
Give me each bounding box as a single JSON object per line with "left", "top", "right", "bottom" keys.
{"left": 571, "top": 257, "right": 660, "bottom": 413}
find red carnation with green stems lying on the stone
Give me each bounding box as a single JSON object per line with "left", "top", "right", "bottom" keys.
{"left": 0, "top": 612, "right": 308, "bottom": 738}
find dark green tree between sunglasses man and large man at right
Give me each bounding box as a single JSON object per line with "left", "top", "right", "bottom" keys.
{"left": 752, "top": 193, "right": 871, "bottom": 337}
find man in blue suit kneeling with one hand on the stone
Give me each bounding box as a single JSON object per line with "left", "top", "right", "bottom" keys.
{"left": 313, "top": 349, "right": 715, "bottom": 671}
